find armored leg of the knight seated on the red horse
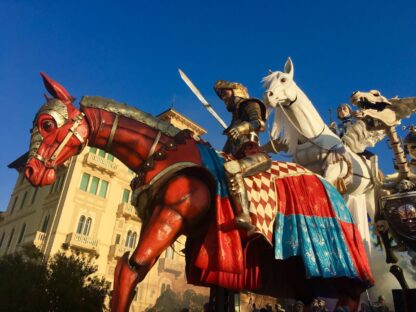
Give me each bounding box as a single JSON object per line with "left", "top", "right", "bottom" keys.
{"left": 224, "top": 153, "right": 271, "bottom": 231}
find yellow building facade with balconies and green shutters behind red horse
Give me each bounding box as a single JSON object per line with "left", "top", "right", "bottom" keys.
{"left": 0, "top": 109, "right": 209, "bottom": 311}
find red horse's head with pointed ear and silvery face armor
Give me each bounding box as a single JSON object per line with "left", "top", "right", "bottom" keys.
{"left": 25, "top": 73, "right": 89, "bottom": 186}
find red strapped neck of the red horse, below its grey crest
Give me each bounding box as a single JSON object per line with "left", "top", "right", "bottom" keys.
{"left": 83, "top": 107, "right": 169, "bottom": 171}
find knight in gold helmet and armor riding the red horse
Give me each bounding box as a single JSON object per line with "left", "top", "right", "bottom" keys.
{"left": 214, "top": 80, "right": 271, "bottom": 230}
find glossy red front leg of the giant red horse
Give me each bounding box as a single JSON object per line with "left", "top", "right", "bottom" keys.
{"left": 111, "top": 176, "right": 210, "bottom": 312}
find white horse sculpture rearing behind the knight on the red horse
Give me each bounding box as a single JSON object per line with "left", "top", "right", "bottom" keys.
{"left": 263, "top": 58, "right": 375, "bottom": 248}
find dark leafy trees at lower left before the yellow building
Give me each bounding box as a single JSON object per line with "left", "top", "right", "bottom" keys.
{"left": 0, "top": 246, "right": 109, "bottom": 312}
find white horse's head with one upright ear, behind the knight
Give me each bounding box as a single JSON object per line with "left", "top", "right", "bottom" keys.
{"left": 262, "top": 57, "right": 299, "bottom": 107}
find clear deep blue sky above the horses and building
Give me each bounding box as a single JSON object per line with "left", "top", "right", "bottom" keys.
{"left": 0, "top": 0, "right": 416, "bottom": 210}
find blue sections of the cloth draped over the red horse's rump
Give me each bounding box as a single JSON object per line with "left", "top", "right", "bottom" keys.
{"left": 274, "top": 179, "right": 359, "bottom": 278}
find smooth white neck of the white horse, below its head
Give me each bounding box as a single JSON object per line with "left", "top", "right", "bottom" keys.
{"left": 288, "top": 89, "right": 326, "bottom": 142}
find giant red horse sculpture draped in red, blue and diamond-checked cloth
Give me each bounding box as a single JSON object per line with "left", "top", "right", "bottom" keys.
{"left": 25, "top": 74, "right": 372, "bottom": 311}
